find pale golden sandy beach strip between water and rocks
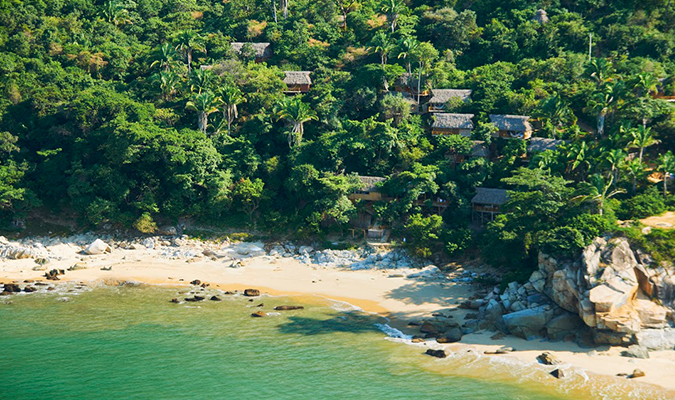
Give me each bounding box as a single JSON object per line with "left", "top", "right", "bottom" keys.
{"left": 0, "top": 236, "right": 675, "bottom": 396}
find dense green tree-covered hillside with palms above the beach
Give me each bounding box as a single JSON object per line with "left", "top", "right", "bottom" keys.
{"left": 0, "top": 0, "right": 675, "bottom": 276}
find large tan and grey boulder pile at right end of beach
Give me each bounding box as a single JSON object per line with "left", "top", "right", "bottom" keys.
{"left": 470, "top": 238, "right": 675, "bottom": 358}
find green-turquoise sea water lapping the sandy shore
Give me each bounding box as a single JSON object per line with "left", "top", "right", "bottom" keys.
{"left": 0, "top": 286, "right": 665, "bottom": 400}
